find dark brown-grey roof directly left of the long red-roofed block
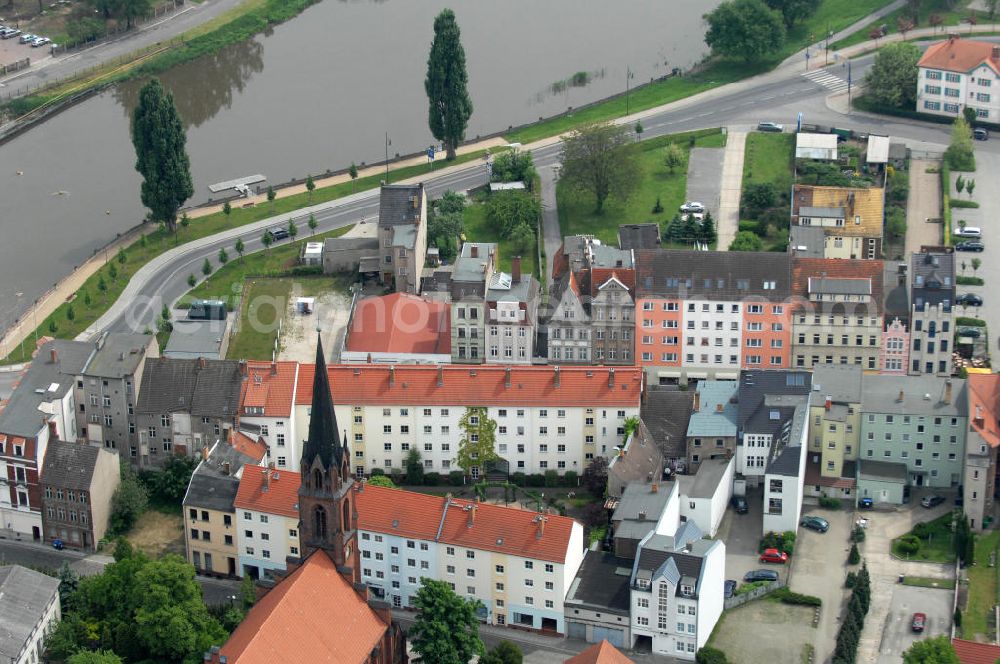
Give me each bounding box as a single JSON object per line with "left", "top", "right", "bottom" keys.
{"left": 135, "top": 357, "right": 243, "bottom": 418}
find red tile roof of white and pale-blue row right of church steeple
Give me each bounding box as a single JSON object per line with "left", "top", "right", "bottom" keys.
{"left": 355, "top": 484, "right": 575, "bottom": 563}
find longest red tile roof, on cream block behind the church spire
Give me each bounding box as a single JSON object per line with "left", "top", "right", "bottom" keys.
{"left": 295, "top": 364, "right": 642, "bottom": 408}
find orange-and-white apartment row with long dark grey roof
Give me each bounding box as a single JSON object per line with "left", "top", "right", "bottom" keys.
{"left": 635, "top": 250, "right": 791, "bottom": 384}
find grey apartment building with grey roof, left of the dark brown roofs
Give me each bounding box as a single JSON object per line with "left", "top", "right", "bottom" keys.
{"left": 77, "top": 332, "right": 160, "bottom": 454}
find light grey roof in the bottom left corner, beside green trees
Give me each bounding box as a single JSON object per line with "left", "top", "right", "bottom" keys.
{"left": 0, "top": 565, "right": 59, "bottom": 661}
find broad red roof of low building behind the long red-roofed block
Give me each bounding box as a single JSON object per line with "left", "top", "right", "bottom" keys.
{"left": 347, "top": 293, "right": 451, "bottom": 355}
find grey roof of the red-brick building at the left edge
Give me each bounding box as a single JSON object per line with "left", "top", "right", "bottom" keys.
{"left": 0, "top": 339, "right": 94, "bottom": 438}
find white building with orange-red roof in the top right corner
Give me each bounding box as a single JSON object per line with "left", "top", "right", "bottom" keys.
{"left": 916, "top": 35, "right": 1000, "bottom": 123}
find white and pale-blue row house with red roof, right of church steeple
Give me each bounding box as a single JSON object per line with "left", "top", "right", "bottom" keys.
{"left": 355, "top": 484, "right": 584, "bottom": 634}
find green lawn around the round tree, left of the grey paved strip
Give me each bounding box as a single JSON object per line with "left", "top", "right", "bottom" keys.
{"left": 556, "top": 128, "right": 725, "bottom": 245}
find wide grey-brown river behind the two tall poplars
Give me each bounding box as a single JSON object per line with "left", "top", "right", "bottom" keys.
{"left": 0, "top": 0, "right": 720, "bottom": 328}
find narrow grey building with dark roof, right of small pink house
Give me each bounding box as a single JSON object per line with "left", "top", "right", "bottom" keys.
{"left": 907, "top": 252, "right": 955, "bottom": 377}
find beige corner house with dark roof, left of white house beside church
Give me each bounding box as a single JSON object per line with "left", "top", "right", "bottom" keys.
{"left": 182, "top": 433, "right": 267, "bottom": 578}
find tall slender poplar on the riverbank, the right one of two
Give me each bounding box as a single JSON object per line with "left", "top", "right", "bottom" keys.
{"left": 424, "top": 9, "right": 472, "bottom": 159}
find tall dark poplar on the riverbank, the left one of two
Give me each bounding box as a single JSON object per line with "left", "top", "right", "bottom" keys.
{"left": 132, "top": 78, "right": 194, "bottom": 232}
